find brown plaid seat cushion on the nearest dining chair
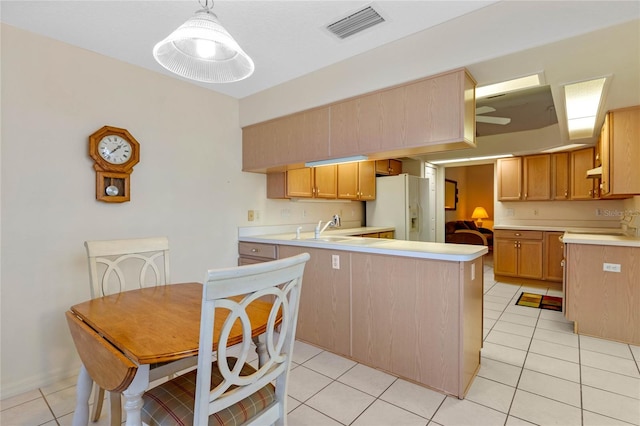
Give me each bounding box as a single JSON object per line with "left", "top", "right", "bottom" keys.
{"left": 142, "top": 358, "right": 276, "bottom": 426}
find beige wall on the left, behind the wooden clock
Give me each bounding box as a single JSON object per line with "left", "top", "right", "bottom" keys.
{"left": 0, "top": 25, "right": 362, "bottom": 398}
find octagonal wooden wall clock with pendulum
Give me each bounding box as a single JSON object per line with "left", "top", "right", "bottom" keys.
{"left": 89, "top": 126, "right": 140, "bottom": 203}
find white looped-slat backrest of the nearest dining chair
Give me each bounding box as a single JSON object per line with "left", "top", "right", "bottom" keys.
{"left": 194, "top": 253, "right": 309, "bottom": 424}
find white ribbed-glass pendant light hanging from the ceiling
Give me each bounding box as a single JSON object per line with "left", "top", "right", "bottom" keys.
{"left": 153, "top": 0, "right": 254, "bottom": 83}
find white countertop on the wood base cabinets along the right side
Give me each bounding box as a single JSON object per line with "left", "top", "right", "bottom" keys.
{"left": 494, "top": 225, "right": 640, "bottom": 247}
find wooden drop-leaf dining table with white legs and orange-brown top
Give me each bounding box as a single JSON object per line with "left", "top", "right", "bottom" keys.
{"left": 66, "top": 283, "right": 272, "bottom": 426}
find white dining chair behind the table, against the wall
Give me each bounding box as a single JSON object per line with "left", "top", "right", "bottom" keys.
{"left": 84, "top": 237, "right": 196, "bottom": 426}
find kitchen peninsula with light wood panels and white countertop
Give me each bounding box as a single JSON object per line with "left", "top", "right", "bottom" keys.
{"left": 239, "top": 228, "right": 488, "bottom": 399}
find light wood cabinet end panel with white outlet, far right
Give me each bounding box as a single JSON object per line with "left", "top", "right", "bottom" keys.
{"left": 564, "top": 244, "right": 640, "bottom": 345}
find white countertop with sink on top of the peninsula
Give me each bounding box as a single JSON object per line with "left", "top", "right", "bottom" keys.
{"left": 239, "top": 227, "right": 488, "bottom": 262}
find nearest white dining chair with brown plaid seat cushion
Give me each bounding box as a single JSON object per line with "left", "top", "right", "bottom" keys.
{"left": 142, "top": 253, "right": 309, "bottom": 426}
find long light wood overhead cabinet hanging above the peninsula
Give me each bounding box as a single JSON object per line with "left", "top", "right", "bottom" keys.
{"left": 242, "top": 68, "right": 476, "bottom": 172}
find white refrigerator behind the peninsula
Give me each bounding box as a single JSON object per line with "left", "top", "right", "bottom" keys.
{"left": 366, "top": 173, "right": 435, "bottom": 241}
